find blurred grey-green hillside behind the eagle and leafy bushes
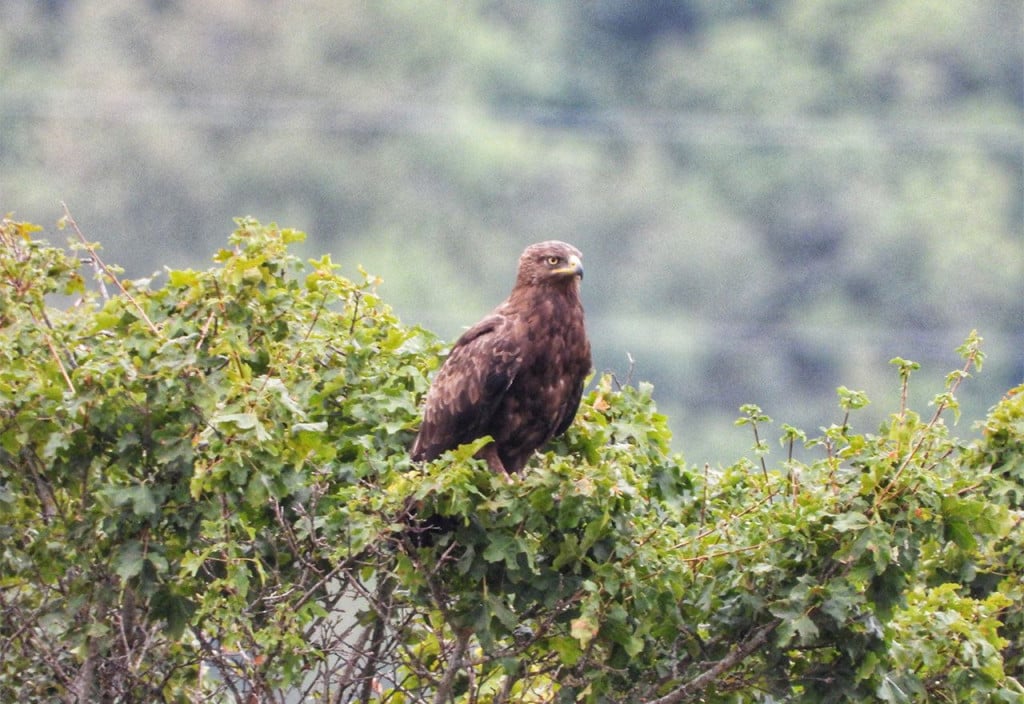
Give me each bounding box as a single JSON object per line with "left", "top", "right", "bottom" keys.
{"left": 0, "top": 0, "right": 1024, "bottom": 465}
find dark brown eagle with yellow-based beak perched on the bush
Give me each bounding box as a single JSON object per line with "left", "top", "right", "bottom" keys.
{"left": 411, "top": 240, "right": 591, "bottom": 474}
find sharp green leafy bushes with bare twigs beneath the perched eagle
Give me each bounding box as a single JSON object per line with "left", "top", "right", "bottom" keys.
{"left": 0, "top": 218, "right": 1024, "bottom": 704}
